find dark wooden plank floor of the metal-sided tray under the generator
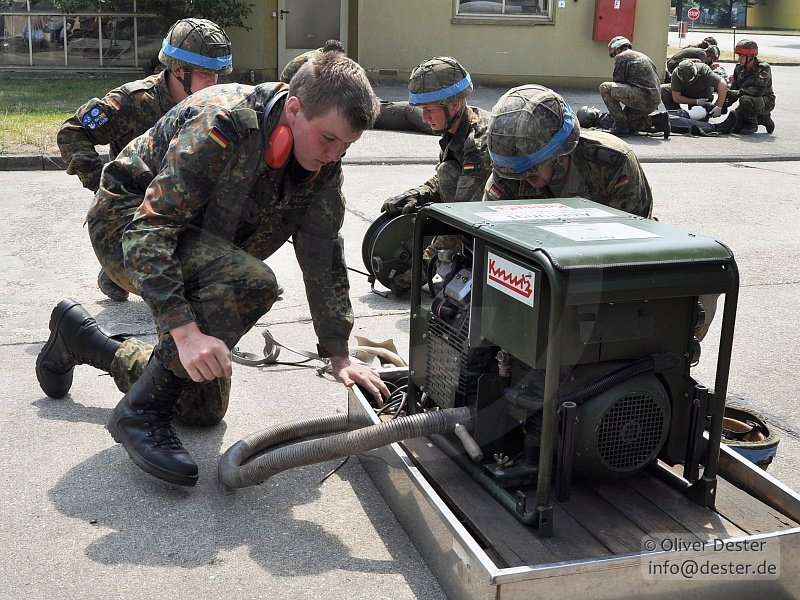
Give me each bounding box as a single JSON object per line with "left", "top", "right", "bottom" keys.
{"left": 402, "top": 438, "right": 798, "bottom": 567}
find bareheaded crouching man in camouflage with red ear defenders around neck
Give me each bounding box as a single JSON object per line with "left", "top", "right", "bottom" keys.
{"left": 36, "top": 53, "right": 389, "bottom": 485}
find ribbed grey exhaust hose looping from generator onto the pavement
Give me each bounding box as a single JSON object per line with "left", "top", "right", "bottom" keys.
{"left": 218, "top": 407, "right": 476, "bottom": 488}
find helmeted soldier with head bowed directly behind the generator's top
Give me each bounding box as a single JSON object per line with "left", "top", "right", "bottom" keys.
{"left": 484, "top": 85, "right": 653, "bottom": 218}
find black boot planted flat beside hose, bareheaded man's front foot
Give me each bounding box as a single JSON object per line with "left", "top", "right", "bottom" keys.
{"left": 106, "top": 356, "right": 197, "bottom": 486}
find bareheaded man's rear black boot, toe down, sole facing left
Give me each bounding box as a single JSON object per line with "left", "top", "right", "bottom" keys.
{"left": 36, "top": 298, "right": 122, "bottom": 398}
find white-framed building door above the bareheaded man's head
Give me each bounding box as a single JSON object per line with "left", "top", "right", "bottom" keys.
{"left": 277, "top": 0, "right": 348, "bottom": 73}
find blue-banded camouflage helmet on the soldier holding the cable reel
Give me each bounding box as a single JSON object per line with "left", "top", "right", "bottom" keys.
{"left": 408, "top": 56, "right": 472, "bottom": 106}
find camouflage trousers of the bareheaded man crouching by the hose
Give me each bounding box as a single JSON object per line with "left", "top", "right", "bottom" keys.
{"left": 87, "top": 219, "right": 278, "bottom": 425}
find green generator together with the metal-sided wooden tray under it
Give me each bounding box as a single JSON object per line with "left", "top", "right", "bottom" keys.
{"left": 349, "top": 198, "right": 800, "bottom": 600}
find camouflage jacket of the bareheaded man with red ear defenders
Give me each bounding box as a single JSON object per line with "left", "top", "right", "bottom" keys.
{"left": 89, "top": 83, "right": 353, "bottom": 355}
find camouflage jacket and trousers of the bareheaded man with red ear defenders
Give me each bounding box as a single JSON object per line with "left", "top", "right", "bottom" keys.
{"left": 87, "top": 83, "right": 353, "bottom": 422}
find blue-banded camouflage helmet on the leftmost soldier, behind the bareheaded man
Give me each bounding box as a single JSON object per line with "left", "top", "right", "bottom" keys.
{"left": 158, "top": 19, "right": 233, "bottom": 74}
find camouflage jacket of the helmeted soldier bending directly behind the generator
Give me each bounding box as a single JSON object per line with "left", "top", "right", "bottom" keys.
{"left": 483, "top": 130, "right": 653, "bottom": 218}
